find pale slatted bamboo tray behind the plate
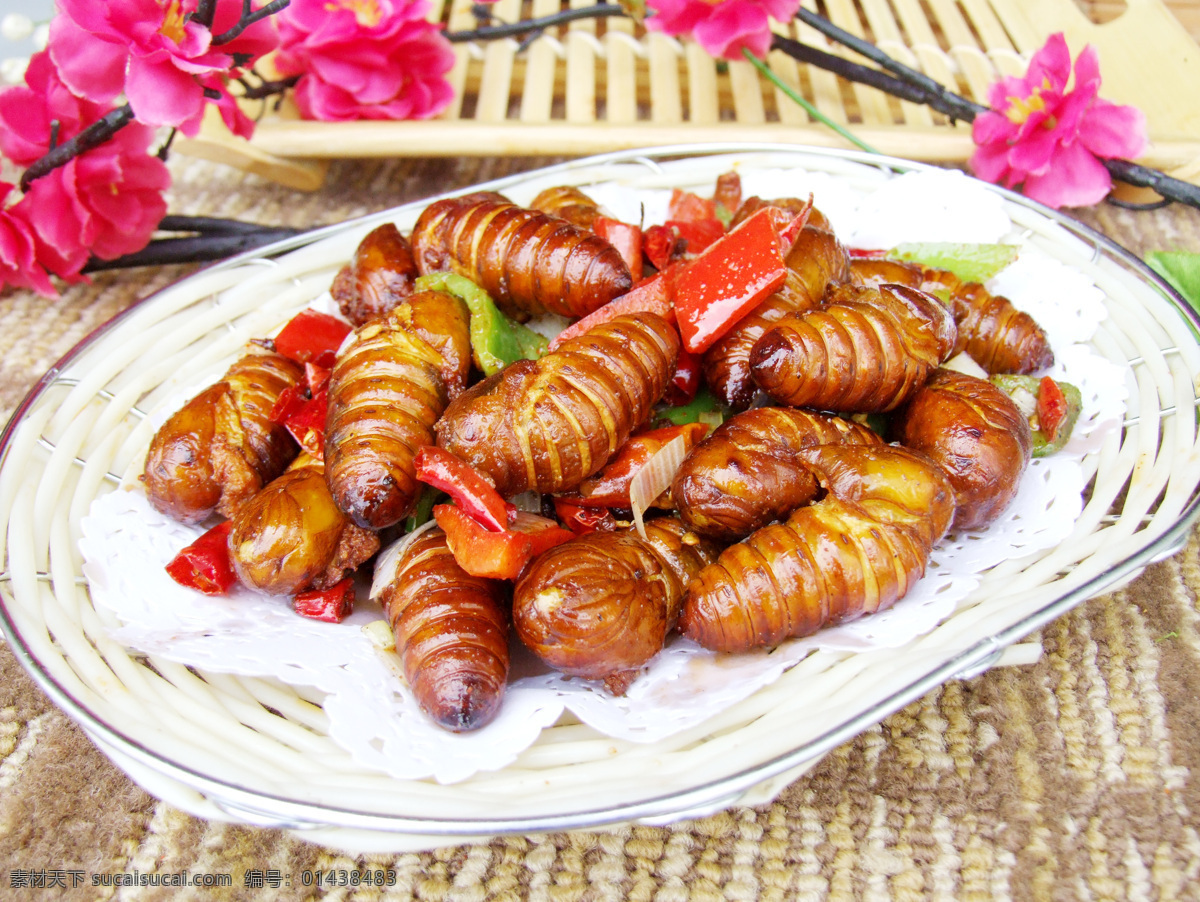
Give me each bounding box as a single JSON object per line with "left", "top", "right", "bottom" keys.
{"left": 176, "top": 0, "right": 1200, "bottom": 190}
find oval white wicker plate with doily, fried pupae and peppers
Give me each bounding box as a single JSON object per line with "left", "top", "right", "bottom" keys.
{"left": 0, "top": 145, "right": 1200, "bottom": 849}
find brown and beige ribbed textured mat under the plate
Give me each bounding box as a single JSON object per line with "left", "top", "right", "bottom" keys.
{"left": 0, "top": 158, "right": 1200, "bottom": 902}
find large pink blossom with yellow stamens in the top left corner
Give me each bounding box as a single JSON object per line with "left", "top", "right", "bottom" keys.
{"left": 49, "top": 0, "right": 275, "bottom": 136}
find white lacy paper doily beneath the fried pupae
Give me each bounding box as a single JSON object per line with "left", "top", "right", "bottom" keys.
{"left": 79, "top": 170, "right": 1128, "bottom": 782}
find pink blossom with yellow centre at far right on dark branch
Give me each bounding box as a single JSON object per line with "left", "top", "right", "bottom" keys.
{"left": 971, "top": 34, "right": 1146, "bottom": 208}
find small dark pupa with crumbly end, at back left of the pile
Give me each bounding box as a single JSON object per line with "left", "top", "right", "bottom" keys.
{"left": 330, "top": 222, "right": 420, "bottom": 326}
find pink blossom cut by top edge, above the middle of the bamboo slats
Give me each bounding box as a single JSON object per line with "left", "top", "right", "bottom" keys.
{"left": 646, "top": 0, "right": 800, "bottom": 60}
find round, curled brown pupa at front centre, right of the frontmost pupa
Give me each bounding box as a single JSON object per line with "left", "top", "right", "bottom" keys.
{"left": 512, "top": 517, "right": 720, "bottom": 694}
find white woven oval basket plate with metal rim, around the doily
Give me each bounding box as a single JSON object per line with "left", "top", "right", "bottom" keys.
{"left": 0, "top": 145, "right": 1200, "bottom": 850}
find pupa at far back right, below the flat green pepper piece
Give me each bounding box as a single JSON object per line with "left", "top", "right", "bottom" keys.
{"left": 853, "top": 259, "right": 1054, "bottom": 374}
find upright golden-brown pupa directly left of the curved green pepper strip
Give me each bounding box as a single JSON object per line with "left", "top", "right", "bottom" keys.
{"left": 325, "top": 291, "right": 470, "bottom": 529}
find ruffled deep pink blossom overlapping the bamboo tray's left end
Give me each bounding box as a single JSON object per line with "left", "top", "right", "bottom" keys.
{"left": 275, "top": 0, "right": 454, "bottom": 121}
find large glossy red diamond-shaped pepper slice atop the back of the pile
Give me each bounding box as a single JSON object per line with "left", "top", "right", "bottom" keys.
{"left": 674, "top": 209, "right": 787, "bottom": 354}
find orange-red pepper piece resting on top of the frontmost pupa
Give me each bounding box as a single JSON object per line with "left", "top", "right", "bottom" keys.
{"left": 433, "top": 504, "right": 575, "bottom": 579}
